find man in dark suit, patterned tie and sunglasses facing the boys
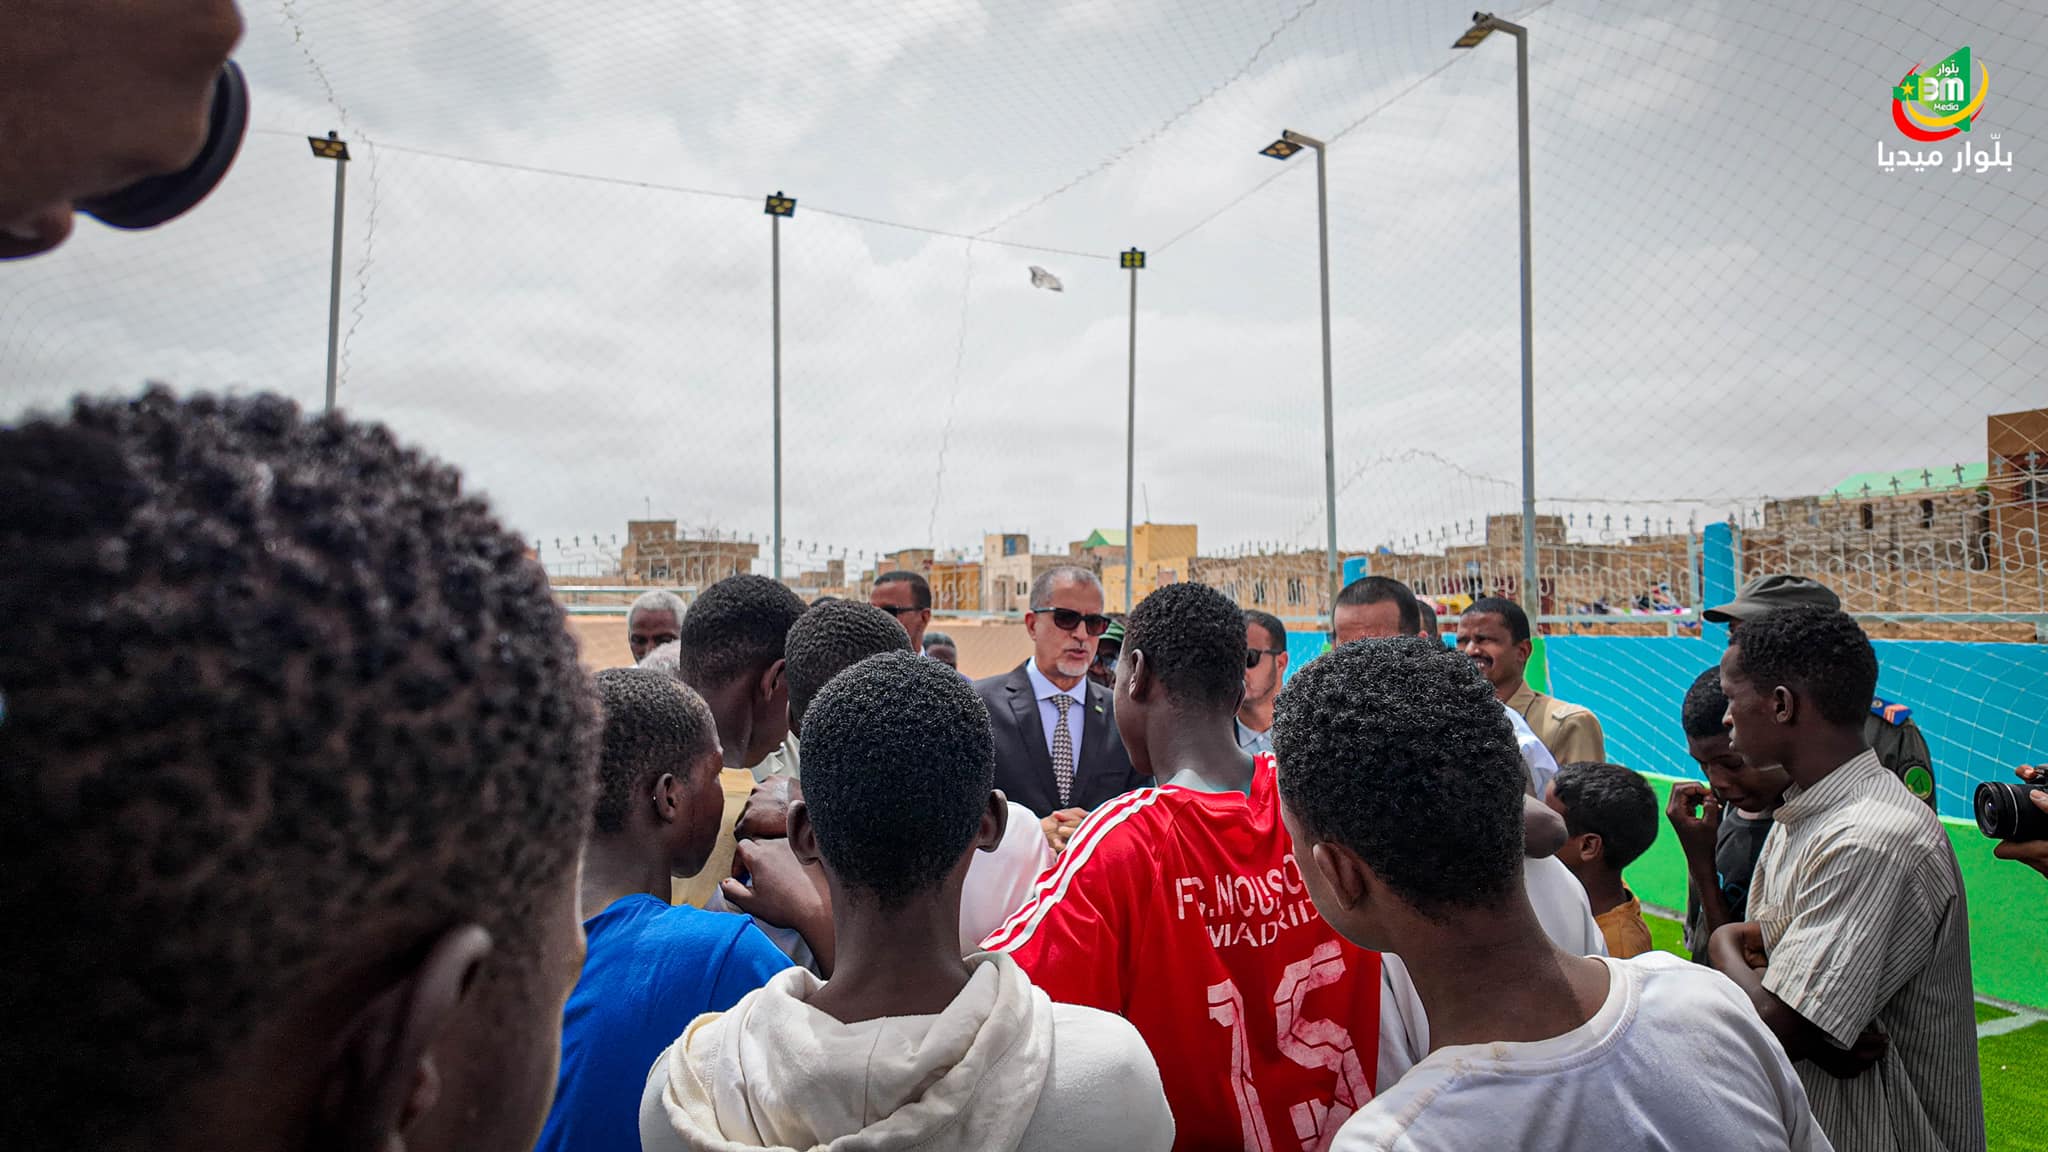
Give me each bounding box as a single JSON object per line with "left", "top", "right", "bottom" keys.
{"left": 975, "top": 568, "right": 1151, "bottom": 849}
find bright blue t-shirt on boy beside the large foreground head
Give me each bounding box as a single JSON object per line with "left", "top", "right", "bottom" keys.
{"left": 535, "top": 896, "right": 788, "bottom": 1152}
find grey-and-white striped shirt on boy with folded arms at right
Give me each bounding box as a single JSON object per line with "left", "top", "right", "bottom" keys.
{"left": 1749, "top": 752, "right": 1985, "bottom": 1152}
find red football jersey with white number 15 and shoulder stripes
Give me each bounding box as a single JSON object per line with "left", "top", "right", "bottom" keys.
{"left": 983, "top": 754, "right": 1425, "bottom": 1152}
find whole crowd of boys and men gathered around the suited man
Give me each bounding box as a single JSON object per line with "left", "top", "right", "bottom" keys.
{"left": 0, "top": 389, "right": 2015, "bottom": 1150}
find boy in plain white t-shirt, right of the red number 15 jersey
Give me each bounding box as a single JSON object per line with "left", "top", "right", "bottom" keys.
{"left": 1274, "top": 637, "right": 1829, "bottom": 1152}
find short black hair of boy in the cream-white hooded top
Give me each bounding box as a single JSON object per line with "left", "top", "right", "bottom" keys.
{"left": 803, "top": 652, "right": 995, "bottom": 906}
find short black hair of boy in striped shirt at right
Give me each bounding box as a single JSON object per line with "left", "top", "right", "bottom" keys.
{"left": 1733, "top": 605, "right": 1878, "bottom": 728}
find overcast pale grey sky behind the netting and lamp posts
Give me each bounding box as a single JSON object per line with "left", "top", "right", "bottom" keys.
{"left": 0, "top": 0, "right": 2048, "bottom": 560}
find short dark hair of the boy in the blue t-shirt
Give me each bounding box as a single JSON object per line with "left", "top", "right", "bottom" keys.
{"left": 592, "top": 654, "right": 719, "bottom": 834}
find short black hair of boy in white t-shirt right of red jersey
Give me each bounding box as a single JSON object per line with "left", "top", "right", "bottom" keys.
{"left": 1274, "top": 635, "right": 1528, "bottom": 920}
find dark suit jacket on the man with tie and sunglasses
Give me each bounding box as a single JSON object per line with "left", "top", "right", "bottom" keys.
{"left": 975, "top": 664, "right": 1151, "bottom": 820}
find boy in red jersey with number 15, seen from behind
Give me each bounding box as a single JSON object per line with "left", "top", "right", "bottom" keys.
{"left": 985, "top": 584, "right": 1427, "bottom": 1152}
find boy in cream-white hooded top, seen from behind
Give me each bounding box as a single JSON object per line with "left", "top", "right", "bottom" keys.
{"left": 639, "top": 650, "right": 1174, "bottom": 1152}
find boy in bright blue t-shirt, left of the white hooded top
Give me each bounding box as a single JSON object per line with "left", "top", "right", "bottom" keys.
{"left": 537, "top": 668, "right": 788, "bottom": 1152}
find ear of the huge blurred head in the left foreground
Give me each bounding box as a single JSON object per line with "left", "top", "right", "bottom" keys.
{"left": 313, "top": 924, "right": 492, "bottom": 1152}
